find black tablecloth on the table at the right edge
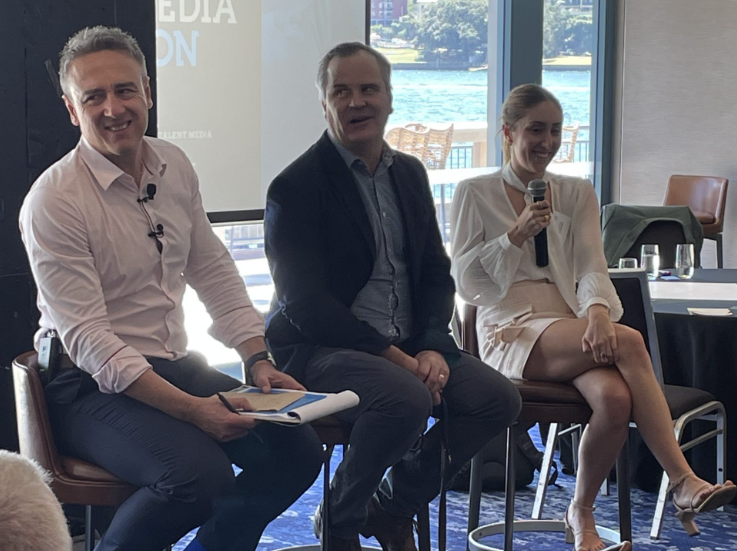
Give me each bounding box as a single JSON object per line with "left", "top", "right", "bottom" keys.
{"left": 638, "top": 270, "right": 737, "bottom": 485}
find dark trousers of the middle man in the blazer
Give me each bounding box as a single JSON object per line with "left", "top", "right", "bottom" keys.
{"left": 306, "top": 348, "right": 521, "bottom": 538}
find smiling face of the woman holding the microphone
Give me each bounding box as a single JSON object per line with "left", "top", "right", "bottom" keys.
{"left": 502, "top": 101, "right": 563, "bottom": 183}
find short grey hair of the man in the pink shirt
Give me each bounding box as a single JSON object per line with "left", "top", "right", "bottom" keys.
{"left": 59, "top": 25, "right": 148, "bottom": 97}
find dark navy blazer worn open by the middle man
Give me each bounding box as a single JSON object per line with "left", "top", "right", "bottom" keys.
{"left": 264, "top": 132, "right": 459, "bottom": 381}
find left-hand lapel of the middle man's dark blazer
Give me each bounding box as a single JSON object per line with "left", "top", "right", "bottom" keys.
{"left": 318, "top": 131, "right": 376, "bottom": 257}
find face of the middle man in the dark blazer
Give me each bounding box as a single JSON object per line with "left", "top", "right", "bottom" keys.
{"left": 322, "top": 51, "right": 392, "bottom": 155}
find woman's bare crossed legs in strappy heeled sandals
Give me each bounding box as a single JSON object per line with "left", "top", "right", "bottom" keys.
{"left": 524, "top": 319, "right": 732, "bottom": 551}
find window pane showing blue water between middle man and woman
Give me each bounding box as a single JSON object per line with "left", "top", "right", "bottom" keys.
{"left": 370, "top": 0, "right": 500, "bottom": 246}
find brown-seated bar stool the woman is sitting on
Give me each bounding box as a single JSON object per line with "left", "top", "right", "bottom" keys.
{"left": 456, "top": 304, "right": 632, "bottom": 551}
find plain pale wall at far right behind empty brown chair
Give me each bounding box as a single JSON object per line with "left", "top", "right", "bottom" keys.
{"left": 613, "top": 0, "right": 737, "bottom": 267}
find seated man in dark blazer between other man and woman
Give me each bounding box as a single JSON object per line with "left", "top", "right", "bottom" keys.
{"left": 265, "top": 43, "right": 520, "bottom": 551}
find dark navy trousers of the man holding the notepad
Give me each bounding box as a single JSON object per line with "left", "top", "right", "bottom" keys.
{"left": 47, "top": 356, "right": 322, "bottom": 551}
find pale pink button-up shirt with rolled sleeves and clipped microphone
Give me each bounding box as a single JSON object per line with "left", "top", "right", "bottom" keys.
{"left": 20, "top": 138, "right": 264, "bottom": 393}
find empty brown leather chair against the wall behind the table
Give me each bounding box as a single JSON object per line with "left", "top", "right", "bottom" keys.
{"left": 663, "top": 174, "right": 729, "bottom": 268}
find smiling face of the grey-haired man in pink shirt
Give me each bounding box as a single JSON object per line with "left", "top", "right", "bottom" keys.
{"left": 64, "top": 50, "right": 153, "bottom": 171}
